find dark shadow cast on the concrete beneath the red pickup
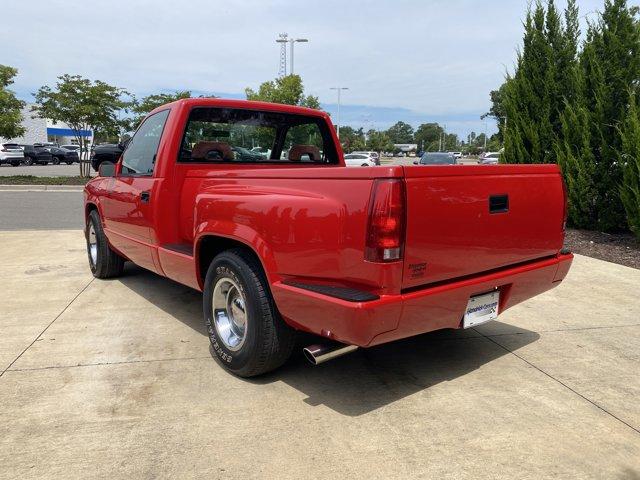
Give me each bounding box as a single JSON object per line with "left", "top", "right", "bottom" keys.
{"left": 119, "top": 266, "right": 540, "bottom": 416}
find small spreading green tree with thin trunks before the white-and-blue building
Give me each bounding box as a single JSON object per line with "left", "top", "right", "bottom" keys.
{"left": 33, "top": 75, "right": 129, "bottom": 176}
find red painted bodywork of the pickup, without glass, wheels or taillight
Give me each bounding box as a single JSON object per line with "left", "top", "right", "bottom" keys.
{"left": 85, "top": 99, "right": 573, "bottom": 346}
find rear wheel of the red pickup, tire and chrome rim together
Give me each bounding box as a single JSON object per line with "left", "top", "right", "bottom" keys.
{"left": 203, "top": 249, "right": 296, "bottom": 377}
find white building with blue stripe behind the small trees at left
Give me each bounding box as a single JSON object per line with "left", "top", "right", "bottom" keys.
{"left": 0, "top": 104, "right": 93, "bottom": 145}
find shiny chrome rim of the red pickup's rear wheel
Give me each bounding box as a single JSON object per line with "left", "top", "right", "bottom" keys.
{"left": 212, "top": 277, "right": 249, "bottom": 352}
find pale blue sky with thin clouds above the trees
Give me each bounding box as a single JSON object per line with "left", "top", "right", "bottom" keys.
{"left": 0, "top": 0, "right": 603, "bottom": 138}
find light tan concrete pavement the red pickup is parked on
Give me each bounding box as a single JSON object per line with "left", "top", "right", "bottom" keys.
{"left": 0, "top": 230, "right": 640, "bottom": 480}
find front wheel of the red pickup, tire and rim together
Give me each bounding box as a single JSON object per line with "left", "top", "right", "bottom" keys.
{"left": 85, "top": 210, "right": 124, "bottom": 278}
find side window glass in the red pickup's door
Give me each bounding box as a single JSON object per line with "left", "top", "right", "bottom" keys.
{"left": 122, "top": 110, "right": 169, "bottom": 175}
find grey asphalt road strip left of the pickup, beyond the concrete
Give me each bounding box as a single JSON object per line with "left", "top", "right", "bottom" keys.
{"left": 0, "top": 190, "right": 83, "bottom": 230}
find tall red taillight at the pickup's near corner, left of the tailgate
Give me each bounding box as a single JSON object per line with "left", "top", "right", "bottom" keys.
{"left": 365, "top": 179, "right": 405, "bottom": 262}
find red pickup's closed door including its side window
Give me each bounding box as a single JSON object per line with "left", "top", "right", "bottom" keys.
{"left": 102, "top": 110, "right": 169, "bottom": 271}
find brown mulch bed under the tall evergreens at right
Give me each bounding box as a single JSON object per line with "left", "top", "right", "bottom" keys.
{"left": 564, "top": 228, "right": 640, "bottom": 269}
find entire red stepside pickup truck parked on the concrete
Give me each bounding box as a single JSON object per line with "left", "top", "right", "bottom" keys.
{"left": 85, "top": 99, "right": 573, "bottom": 377}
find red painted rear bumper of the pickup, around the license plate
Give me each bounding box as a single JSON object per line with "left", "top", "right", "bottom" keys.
{"left": 272, "top": 254, "right": 573, "bottom": 347}
